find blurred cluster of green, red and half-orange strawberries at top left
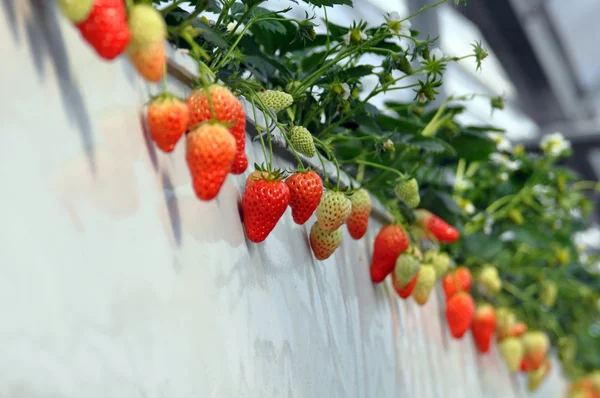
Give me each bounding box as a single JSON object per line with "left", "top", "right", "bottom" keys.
{"left": 59, "top": 0, "right": 167, "bottom": 82}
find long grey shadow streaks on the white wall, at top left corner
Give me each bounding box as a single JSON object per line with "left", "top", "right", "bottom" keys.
{"left": 21, "top": 0, "right": 96, "bottom": 173}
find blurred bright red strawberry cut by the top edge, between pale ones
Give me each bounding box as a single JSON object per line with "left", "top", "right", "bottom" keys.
{"left": 77, "top": 0, "right": 131, "bottom": 59}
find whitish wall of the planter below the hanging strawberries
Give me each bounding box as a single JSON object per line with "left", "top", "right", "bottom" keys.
{"left": 0, "top": 0, "right": 564, "bottom": 398}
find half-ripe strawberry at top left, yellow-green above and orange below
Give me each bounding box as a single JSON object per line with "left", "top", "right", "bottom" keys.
{"left": 127, "top": 4, "right": 167, "bottom": 82}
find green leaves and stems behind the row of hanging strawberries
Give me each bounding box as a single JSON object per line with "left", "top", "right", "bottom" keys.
{"left": 149, "top": 0, "right": 600, "bottom": 378}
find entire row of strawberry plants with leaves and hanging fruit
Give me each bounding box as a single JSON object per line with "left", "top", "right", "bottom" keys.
{"left": 60, "top": 0, "right": 600, "bottom": 391}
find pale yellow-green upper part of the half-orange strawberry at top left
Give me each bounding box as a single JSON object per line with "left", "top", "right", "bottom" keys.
{"left": 129, "top": 4, "right": 167, "bottom": 49}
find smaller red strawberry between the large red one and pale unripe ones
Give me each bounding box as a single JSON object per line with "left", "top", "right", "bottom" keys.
{"left": 285, "top": 171, "right": 324, "bottom": 225}
